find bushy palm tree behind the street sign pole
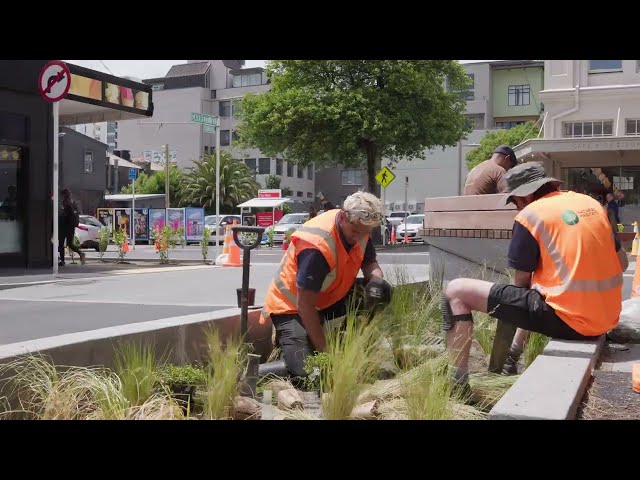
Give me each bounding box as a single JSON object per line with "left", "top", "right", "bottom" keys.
{"left": 181, "top": 152, "right": 260, "bottom": 213}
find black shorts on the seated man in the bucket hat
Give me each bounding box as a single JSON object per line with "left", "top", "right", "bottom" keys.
{"left": 487, "top": 283, "right": 598, "bottom": 340}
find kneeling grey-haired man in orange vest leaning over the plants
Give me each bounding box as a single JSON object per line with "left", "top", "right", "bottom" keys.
{"left": 261, "top": 192, "right": 388, "bottom": 379}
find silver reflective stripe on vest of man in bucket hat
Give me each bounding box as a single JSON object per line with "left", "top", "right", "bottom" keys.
{"left": 519, "top": 204, "right": 623, "bottom": 295}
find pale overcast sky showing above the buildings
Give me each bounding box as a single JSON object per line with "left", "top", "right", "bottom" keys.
{"left": 66, "top": 60, "right": 496, "bottom": 79}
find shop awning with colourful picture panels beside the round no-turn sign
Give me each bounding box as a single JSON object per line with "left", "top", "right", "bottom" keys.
{"left": 60, "top": 63, "right": 153, "bottom": 126}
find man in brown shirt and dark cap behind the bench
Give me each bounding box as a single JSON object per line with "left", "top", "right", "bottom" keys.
{"left": 464, "top": 145, "right": 518, "bottom": 195}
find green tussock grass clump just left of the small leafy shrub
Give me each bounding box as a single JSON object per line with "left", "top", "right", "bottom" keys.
{"left": 114, "top": 342, "right": 162, "bottom": 406}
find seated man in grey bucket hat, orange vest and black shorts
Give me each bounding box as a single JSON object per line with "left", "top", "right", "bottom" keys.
{"left": 441, "top": 162, "right": 628, "bottom": 400}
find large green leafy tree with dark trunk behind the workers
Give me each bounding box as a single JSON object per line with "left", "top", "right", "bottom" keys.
{"left": 238, "top": 60, "right": 470, "bottom": 195}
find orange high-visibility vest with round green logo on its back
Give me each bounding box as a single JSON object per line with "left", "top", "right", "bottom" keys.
{"left": 516, "top": 192, "right": 622, "bottom": 336}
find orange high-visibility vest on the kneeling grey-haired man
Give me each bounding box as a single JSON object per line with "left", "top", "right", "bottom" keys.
{"left": 260, "top": 209, "right": 369, "bottom": 324}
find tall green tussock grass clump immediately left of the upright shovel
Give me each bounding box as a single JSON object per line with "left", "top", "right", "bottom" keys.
{"left": 204, "top": 328, "right": 246, "bottom": 420}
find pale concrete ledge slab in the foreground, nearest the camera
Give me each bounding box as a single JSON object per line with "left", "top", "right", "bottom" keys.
{"left": 489, "top": 355, "right": 592, "bottom": 420}
